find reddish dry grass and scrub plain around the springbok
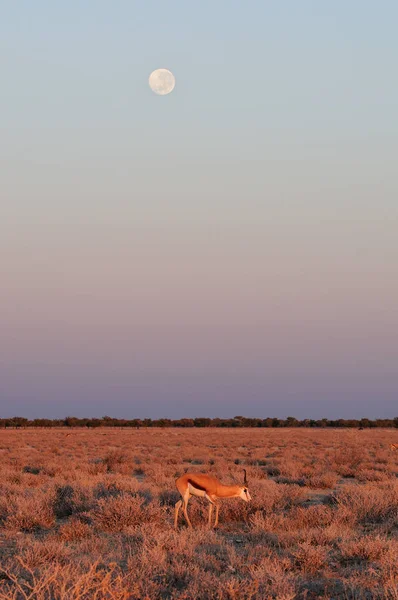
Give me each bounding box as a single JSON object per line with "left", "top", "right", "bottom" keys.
{"left": 0, "top": 429, "right": 398, "bottom": 600}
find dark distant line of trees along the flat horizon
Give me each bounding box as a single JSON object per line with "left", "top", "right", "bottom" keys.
{"left": 0, "top": 416, "right": 398, "bottom": 429}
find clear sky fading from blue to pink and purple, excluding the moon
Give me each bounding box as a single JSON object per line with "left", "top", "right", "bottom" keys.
{"left": 0, "top": 0, "right": 398, "bottom": 418}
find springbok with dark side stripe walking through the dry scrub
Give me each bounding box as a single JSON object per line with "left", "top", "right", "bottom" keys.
{"left": 174, "top": 469, "right": 251, "bottom": 529}
